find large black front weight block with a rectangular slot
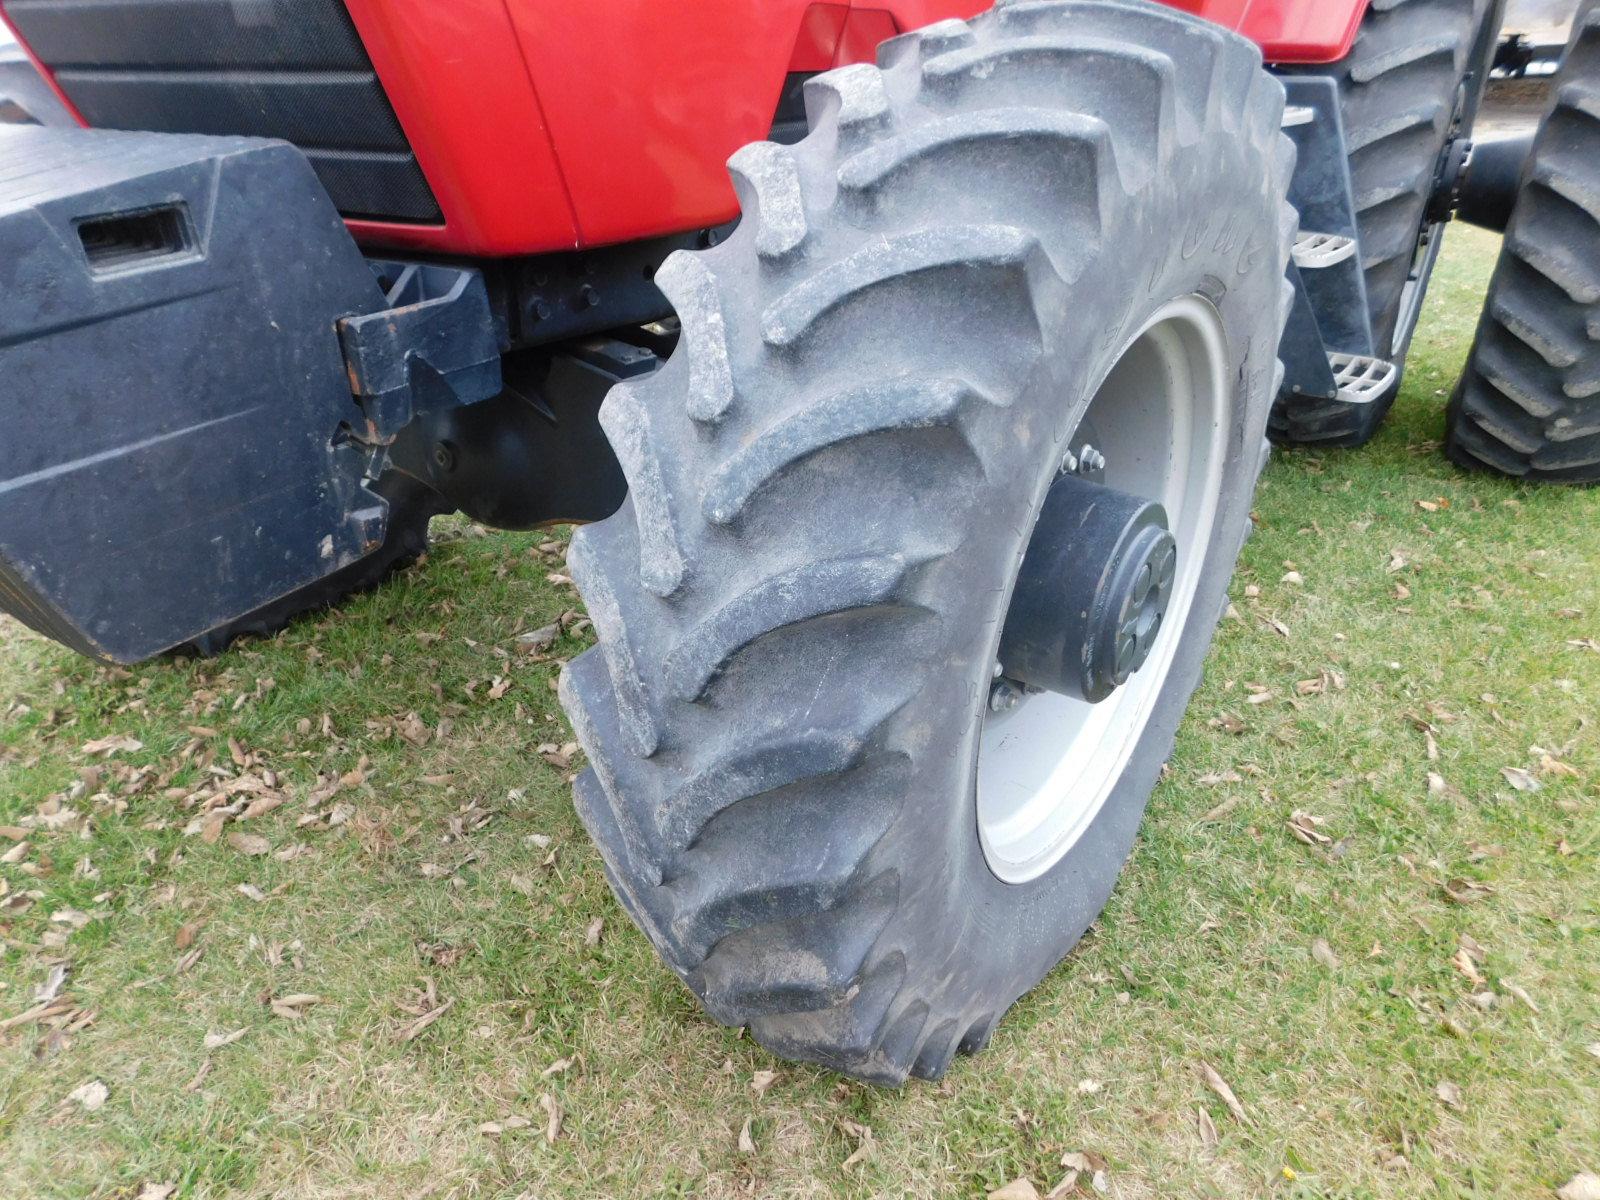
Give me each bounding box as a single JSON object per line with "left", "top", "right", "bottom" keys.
{"left": 0, "top": 126, "right": 409, "bottom": 662}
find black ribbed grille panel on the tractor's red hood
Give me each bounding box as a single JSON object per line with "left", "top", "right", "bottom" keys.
{"left": 5, "top": 0, "right": 440, "bottom": 221}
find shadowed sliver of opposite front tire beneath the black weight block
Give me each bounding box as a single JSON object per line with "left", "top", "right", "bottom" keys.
{"left": 166, "top": 470, "right": 450, "bottom": 658}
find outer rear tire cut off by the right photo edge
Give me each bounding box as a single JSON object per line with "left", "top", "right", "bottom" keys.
{"left": 1445, "top": 3, "right": 1600, "bottom": 483}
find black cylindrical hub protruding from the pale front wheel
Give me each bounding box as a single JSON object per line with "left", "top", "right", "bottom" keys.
{"left": 997, "top": 474, "right": 1178, "bottom": 704}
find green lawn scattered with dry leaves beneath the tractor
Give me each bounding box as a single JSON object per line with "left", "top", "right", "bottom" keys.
{"left": 0, "top": 229, "right": 1600, "bottom": 1198}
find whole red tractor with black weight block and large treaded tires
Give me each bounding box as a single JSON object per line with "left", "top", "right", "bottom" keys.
{"left": 0, "top": 0, "right": 1600, "bottom": 1082}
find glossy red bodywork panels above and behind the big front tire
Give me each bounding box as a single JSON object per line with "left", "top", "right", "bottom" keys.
{"left": 0, "top": 0, "right": 1368, "bottom": 256}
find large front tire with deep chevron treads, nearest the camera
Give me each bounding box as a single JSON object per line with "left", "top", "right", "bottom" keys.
{"left": 562, "top": 0, "right": 1296, "bottom": 1083}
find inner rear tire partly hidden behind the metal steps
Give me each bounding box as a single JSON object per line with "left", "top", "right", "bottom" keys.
{"left": 1272, "top": 0, "right": 1496, "bottom": 446}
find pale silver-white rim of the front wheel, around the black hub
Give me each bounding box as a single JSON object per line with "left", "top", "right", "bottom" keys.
{"left": 978, "top": 296, "right": 1234, "bottom": 883}
